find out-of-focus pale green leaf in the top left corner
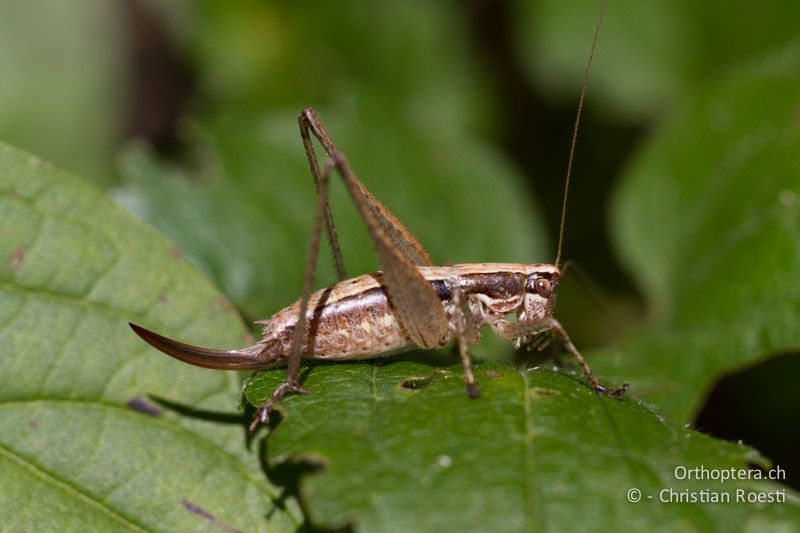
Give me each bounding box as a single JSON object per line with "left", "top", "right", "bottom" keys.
{"left": 0, "top": 0, "right": 124, "bottom": 185}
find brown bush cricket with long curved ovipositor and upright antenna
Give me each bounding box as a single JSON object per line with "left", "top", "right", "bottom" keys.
{"left": 130, "top": 0, "right": 626, "bottom": 431}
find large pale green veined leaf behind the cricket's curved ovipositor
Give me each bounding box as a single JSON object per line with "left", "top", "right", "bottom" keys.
{"left": 0, "top": 145, "right": 299, "bottom": 531}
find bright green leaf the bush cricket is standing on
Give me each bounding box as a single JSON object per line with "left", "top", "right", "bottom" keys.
{"left": 246, "top": 360, "right": 800, "bottom": 531}
